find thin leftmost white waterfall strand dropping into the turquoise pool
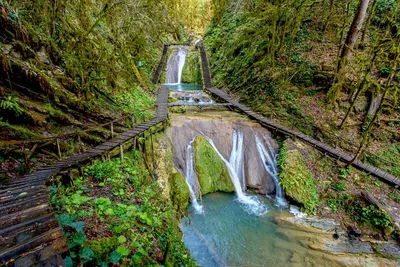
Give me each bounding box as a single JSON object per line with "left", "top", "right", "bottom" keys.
{"left": 185, "top": 139, "right": 203, "bottom": 213}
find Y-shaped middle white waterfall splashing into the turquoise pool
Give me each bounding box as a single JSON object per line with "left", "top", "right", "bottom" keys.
{"left": 203, "top": 130, "right": 267, "bottom": 216}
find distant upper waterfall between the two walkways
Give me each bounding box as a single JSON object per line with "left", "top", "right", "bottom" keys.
{"left": 165, "top": 46, "right": 188, "bottom": 85}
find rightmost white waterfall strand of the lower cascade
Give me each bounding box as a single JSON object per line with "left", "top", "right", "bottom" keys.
{"left": 255, "top": 136, "right": 287, "bottom": 206}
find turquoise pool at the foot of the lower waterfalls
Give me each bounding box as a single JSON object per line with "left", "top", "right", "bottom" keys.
{"left": 181, "top": 193, "right": 301, "bottom": 267}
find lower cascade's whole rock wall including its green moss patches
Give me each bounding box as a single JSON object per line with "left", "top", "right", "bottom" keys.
{"left": 155, "top": 111, "right": 278, "bottom": 209}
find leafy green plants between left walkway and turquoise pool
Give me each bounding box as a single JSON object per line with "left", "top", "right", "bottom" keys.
{"left": 51, "top": 151, "right": 194, "bottom": 266}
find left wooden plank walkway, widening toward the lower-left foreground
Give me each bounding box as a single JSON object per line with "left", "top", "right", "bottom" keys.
{"left": 0, "top": 86, "right": 168, "bottom": 266}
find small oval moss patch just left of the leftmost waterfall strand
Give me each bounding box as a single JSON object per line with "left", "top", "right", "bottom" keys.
{"left": 170, "top": 172, "right": 190, "bottom": 214}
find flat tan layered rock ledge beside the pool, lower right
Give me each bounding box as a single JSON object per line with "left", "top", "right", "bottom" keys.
{"left": 275, "top": 213, "right": 400, "bottom": 267}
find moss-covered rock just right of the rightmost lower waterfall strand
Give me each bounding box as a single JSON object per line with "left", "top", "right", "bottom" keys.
{"left": 278, "top": 142, "right": 318, "bottom": 214}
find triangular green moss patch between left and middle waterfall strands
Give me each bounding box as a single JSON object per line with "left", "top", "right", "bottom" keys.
{"left": 194, "top": 136, "right": 235, "bottom": 195}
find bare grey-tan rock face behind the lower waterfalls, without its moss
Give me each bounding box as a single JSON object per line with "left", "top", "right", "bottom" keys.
{"left": 167, "top": 111, "right": 278, "bottom": 194}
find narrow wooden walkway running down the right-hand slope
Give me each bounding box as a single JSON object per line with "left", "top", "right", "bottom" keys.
{"left": 197, "top": 45, "right": 400, "bottom": 187}
